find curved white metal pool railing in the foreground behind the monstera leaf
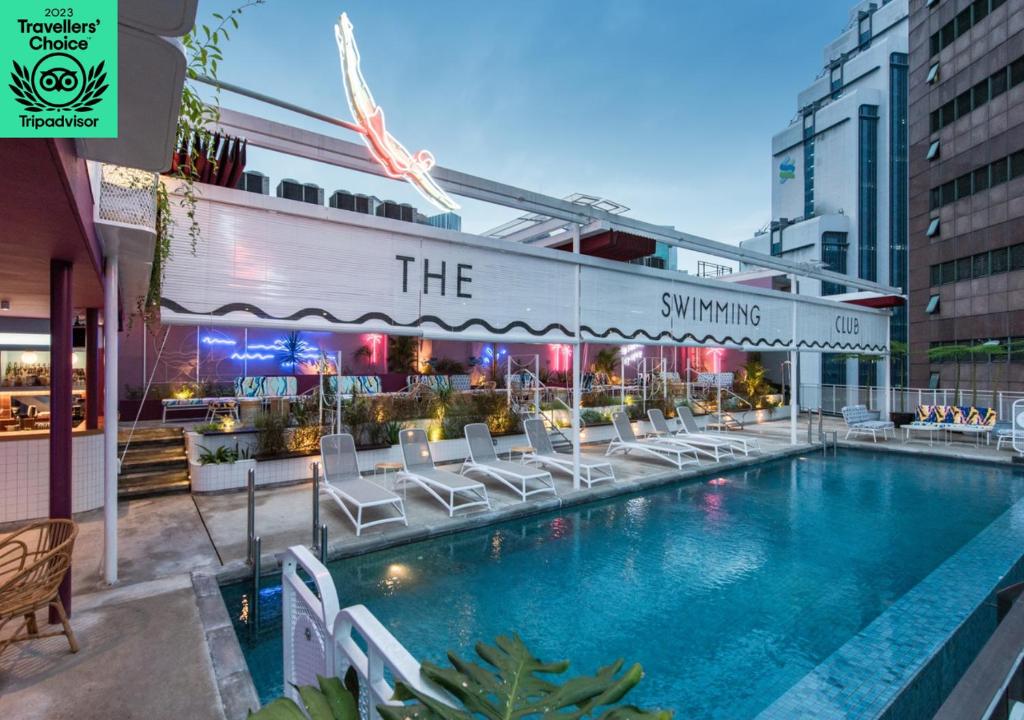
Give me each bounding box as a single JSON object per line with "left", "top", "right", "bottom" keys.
{"left": 282, "top": 545, "right": 454, "bottom": 720}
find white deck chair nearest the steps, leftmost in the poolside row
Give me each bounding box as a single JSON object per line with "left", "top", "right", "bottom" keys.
{"left": 321, "top": 433, "right": 409, "bottom": 536}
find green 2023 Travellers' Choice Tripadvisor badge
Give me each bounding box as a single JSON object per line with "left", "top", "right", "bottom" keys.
{"left": 0, "top": 0, "right": 118, "bottom": 137}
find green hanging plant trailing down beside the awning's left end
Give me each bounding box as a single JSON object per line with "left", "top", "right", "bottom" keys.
{"left": 138, "top": 0, "right": 265, "bottom": 326}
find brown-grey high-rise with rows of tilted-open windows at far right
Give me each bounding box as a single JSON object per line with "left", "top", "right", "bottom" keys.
{"left": 909, "top": 0, "right": 1024, "bottom": 391}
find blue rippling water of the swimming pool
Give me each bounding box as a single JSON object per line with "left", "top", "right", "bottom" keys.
{"left": 223, "top": 451, "right": 1024, "bottom": 718}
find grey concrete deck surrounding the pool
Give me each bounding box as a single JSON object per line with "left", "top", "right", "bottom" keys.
{"left": 0, "top": 416, "right": 1014, "bottom": 720}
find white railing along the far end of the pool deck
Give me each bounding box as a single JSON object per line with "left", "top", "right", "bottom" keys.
{"left": 798, "top": 383, "right": 1024, "bottom": 420}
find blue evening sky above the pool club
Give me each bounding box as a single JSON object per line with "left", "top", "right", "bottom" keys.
{"left": 198, "top": 0, "right": 853, "bottom": 267}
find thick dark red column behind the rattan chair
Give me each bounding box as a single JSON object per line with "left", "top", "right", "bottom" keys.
{"left": 50, "top": 260, "right": 74, "bottom": 623}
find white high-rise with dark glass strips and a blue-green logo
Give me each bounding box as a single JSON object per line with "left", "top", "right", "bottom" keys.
{"left": 741, "top": 0, "right": 908, "bottom": 403}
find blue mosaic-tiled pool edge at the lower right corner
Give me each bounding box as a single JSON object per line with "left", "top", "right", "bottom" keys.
{"left": 758, "top": 500, "right": 1024, "bottom": 720}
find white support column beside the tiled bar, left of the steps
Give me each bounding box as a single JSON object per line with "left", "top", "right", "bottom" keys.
{"left": 103, "top": 255, "right": 118, "bottom": 585}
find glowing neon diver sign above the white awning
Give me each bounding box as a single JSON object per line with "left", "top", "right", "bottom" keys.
{"left": 334, "top": 12, "right": 459, "bottom": 210}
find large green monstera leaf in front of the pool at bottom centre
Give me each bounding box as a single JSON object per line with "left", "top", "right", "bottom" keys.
{"left": 378, "top": 635, "right": 672, "bottom": 720}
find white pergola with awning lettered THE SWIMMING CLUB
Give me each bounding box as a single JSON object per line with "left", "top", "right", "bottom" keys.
{"left": 162, "top": 83, "right": 900, "bottom": 485}
